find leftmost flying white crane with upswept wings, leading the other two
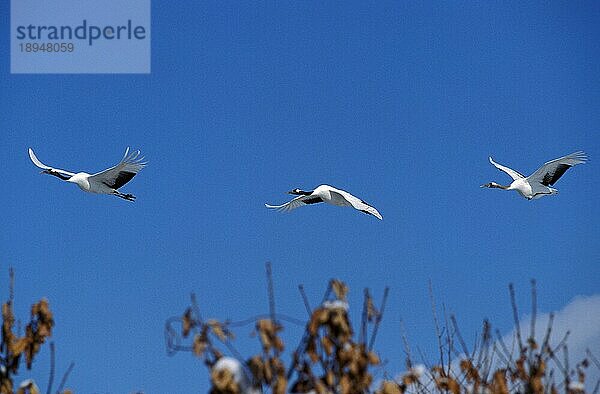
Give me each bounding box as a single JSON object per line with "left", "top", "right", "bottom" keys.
{"left": 29, "top": 148, "right": 146, "bottom": 201}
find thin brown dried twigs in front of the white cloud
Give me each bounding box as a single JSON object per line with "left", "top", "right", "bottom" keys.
{"left": 376, "top": 281, "right": 600, "bottom": 394}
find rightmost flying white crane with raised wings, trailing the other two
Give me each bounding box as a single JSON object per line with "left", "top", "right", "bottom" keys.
{"left": 481, "top": 151, "right": 587, "bottom": 200}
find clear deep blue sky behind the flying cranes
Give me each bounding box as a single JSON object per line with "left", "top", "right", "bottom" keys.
{"left": 0, "top": 0, "right": 600, "bottom": 393}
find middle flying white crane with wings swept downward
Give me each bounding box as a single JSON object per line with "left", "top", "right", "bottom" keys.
{"left": 265, "top": 185, "right": 383, "bottom": 220}
